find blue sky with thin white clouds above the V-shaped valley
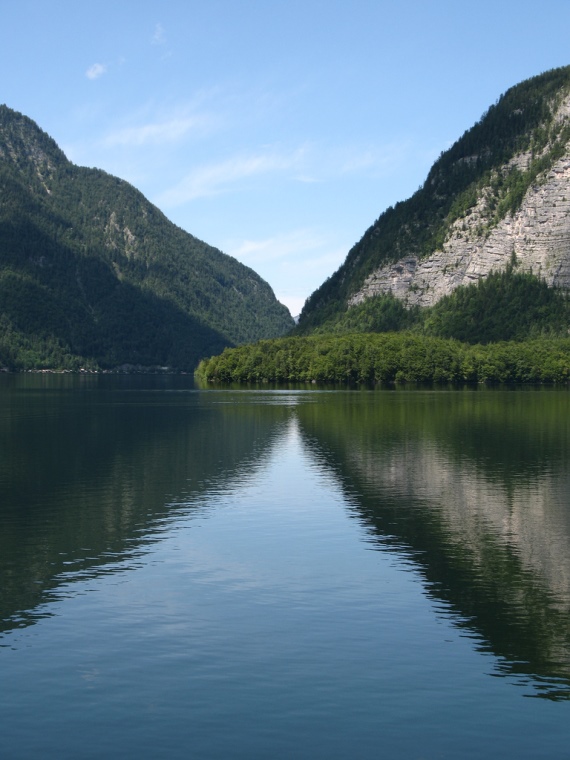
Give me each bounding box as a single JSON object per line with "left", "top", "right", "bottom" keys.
{"left": 0, "top": 0, "right": 570, "bottom": 315}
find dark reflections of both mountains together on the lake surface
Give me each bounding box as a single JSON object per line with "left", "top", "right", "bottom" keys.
{"left": 0, "top": 377, "right": 570, "bottom": 699}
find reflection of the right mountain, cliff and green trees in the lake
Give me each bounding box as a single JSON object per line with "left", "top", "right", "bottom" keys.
{"left": 299, "top": 391, "right": 570, "bottom": 699}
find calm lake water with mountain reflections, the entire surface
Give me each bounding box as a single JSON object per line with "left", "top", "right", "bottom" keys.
{"left": 0, "top": 376, "right": 570, "bottom": 760}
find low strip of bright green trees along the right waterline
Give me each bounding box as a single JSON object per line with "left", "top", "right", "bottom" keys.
{"left": 196, "top": 332, "right": 570, "bottom": 386}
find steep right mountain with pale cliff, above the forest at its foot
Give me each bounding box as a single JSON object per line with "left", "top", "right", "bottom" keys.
{"left": 297, "top": 66, "right": 570, "bottom": 337}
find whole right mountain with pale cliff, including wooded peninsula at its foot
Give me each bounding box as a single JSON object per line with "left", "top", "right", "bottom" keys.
{"left": 199, "top": 67, "right": 570, "bottom": 384}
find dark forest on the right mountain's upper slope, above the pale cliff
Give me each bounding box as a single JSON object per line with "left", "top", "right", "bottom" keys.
{"left": 298, "top": 66, "right": 570, "bottom": 334}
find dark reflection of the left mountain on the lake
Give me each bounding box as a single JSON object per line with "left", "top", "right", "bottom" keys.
{"left": 0, "top": 376, "right": 287, "bottom": 632}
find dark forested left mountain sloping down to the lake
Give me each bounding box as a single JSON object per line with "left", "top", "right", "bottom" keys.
{"left": 0, "top": 106, "right": 294, "bottom": 370}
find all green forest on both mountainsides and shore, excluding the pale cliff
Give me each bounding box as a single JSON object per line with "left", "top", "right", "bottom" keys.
{"left": 0, "top": 67, "right": 570, "bottom": 374}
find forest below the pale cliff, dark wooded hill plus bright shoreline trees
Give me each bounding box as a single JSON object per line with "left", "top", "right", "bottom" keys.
{"left": 197, "top": 265, "right": 570, "bottom": 385}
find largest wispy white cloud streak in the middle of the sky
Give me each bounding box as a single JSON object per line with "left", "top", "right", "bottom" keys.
{"left": 158, "top": 149, "right": 303, "bottom": 206}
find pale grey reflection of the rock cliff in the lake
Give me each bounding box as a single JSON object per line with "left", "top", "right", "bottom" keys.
{"left": 350, "top": 441, "right": 570, "bottom": 613}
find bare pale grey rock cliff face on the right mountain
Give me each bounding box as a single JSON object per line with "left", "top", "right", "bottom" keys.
{"left": 348, "top": 97, "right": 570, "bottom": 307}
